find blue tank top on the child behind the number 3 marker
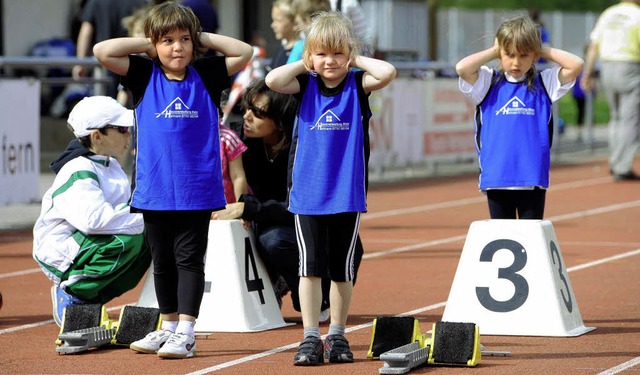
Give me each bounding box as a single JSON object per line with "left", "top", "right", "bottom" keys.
{"left": 475, "top": 74, "right": 553, "bottom": 190}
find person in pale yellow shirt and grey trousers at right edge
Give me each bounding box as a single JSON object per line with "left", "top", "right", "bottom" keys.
{"left": 580, "top": 0, "right": 640, "bottom": 181}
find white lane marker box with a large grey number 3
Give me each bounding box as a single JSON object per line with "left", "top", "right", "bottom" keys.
{"left": 442, "top": 220, "right": 595, "bottom": 336}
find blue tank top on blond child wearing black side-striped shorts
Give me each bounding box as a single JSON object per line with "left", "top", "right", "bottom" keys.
{"left": 289, "top": 72, "right": 367, "bottom": 215}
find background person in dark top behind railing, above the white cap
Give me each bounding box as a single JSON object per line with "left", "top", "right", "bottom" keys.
{"left": 71, "top": 0, "right": 147, "bottom": 98}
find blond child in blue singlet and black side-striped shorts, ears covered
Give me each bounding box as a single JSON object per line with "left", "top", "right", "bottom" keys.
{"left": 266, "top": 12, "right": 396, "bottom": 366}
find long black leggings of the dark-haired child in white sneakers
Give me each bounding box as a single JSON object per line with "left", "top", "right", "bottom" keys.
{"left": 143, "top": 211, "right": 211, "bottom": 318}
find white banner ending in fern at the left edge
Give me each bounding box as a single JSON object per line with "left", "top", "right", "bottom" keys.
{"left": 0, "top": 79, "right": 41, "bottom": 205}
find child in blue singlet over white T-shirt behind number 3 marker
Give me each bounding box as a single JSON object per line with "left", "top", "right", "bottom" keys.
{"left": 456, "top": 16, "right": 583, "bottom": 220}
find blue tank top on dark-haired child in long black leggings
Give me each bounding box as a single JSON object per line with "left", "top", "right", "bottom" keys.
{"left": 131, "top": 62, "right": 226, "bottom": 211}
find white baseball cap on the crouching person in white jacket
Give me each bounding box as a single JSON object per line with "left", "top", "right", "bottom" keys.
{"left": 67, "top": 96, "right": 133, "bottom": 138}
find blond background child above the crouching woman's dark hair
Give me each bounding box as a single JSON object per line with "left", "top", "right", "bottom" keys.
{"left": 268, "top": 0, "right": 300, "bottom": 70}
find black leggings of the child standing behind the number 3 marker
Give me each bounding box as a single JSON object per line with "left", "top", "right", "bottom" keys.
{"left": 487, "top": 188, "right": 547, "bottom": 220}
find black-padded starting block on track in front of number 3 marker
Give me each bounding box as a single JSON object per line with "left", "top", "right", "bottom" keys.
{"left": 368, "top": 317, "right": 482, "bottom": 374}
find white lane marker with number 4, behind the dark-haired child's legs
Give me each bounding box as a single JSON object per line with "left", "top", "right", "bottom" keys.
{"left": 137, "top": 220, "right": 290, "bottom": 333}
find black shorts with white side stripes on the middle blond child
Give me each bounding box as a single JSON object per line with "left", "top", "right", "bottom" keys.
{"left": 295, "top": 212, "right": 360, "bottom": 282}
